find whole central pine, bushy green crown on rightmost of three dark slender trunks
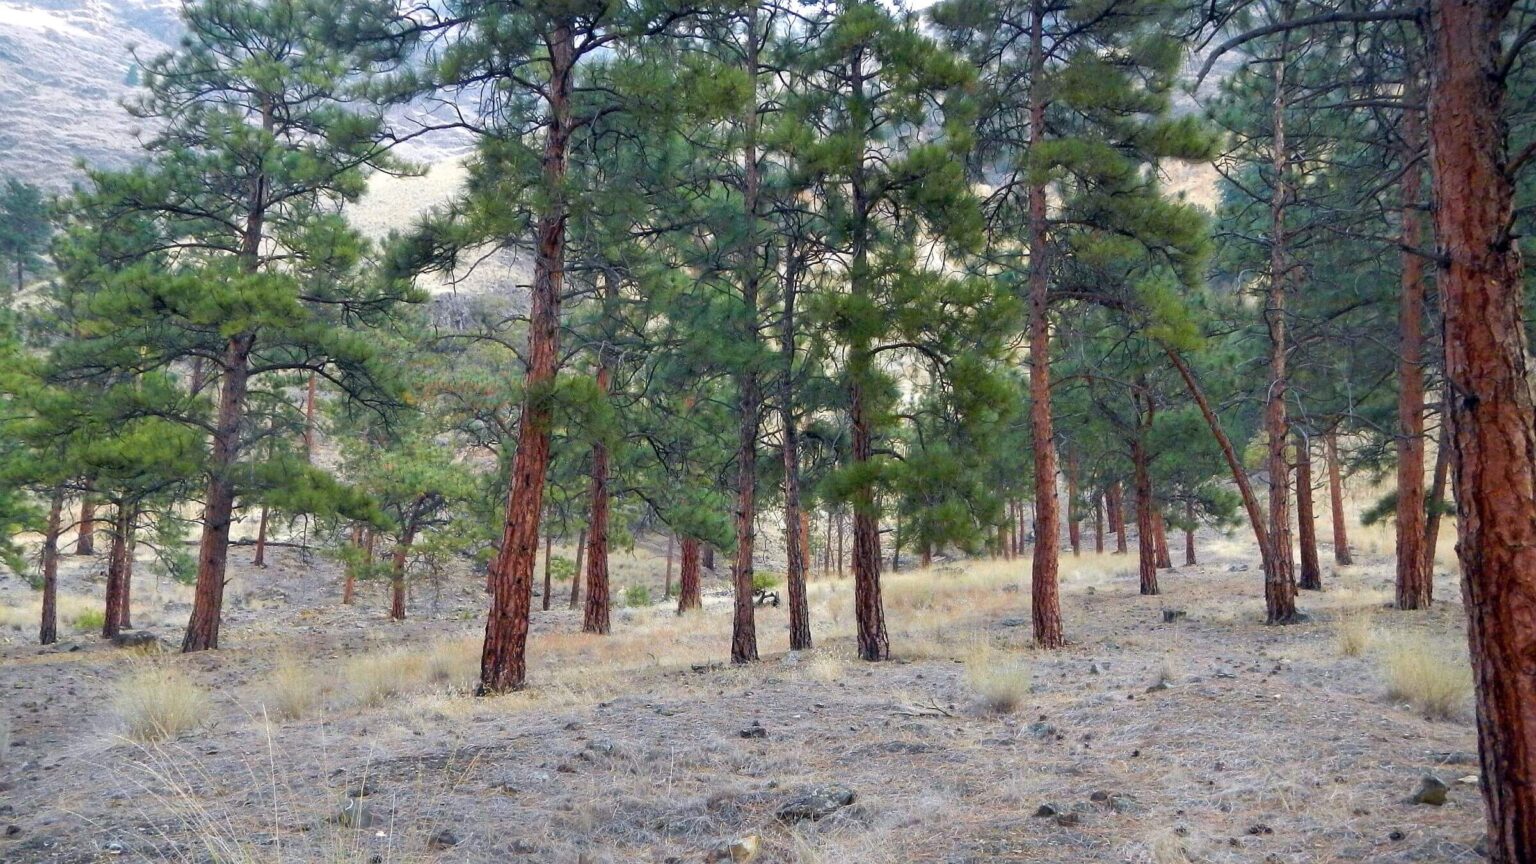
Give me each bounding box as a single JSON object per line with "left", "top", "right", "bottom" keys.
{"left": 791, "top": 0, "right": 977, "bottom": 661}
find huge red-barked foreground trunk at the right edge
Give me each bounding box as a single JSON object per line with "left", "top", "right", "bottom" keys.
{"left": 1428, "top": 0, "right": 1536, "bottom": 864}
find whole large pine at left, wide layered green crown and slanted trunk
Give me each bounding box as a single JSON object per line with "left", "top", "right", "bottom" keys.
{"left": 86, "top": 0, "right": 409, "bottom": 652}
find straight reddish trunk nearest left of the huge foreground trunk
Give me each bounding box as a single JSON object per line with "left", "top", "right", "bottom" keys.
{"left": 1398, "top": 75, "right": 1435, "bottom": 609}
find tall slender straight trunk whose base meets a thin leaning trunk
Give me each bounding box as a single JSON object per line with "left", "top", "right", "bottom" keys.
{"left": 1264, "top": 20, "right": 1296, "bottom": 624}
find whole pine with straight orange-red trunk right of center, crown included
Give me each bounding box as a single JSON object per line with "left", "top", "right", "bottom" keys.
{"left": 932, "top": 0, "right": 1210, "bottom": 647}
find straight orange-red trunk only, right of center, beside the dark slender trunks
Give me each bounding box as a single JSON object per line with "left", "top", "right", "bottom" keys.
{"left": 1028, "top": 0, "right": 1066, "bottom": 649}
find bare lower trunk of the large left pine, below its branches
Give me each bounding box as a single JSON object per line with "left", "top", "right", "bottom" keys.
{"left": 181, "top": 334, "right": 257, "bottom": 652}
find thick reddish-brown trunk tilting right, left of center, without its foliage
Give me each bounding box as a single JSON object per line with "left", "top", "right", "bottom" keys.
{"left": 476, "top": 20, "right": 576, "bottom": 695}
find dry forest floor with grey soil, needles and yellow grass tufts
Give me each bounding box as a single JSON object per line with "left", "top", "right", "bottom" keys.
{"left": 0, "top": 522, "right": 1482, "bottom": 864}
